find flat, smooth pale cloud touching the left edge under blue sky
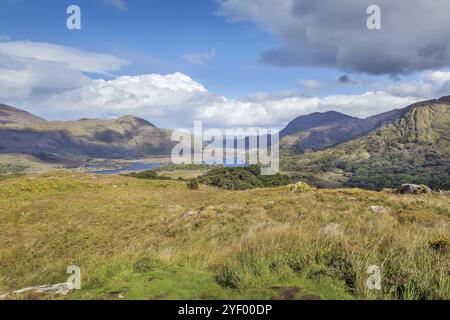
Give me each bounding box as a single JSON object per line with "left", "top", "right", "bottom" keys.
{"left": 0, "top": 41, "right": 128, "bottom": 103}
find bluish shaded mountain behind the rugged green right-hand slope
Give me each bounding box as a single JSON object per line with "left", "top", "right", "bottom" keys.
{"left": 280, "top": 110, "right": 399, "bottom": 154}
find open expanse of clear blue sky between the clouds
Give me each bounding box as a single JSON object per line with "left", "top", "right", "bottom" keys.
{"left": 0, "top": 0, "right": 316, "bottom": 97}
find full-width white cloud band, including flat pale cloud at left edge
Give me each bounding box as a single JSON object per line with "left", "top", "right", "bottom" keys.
{"left": 0, "top": 42, "right": 442, "bottom": 128}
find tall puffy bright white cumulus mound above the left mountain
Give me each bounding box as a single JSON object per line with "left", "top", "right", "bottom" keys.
{"left": 39, "top": 73, "right": 214, "bottom": 125}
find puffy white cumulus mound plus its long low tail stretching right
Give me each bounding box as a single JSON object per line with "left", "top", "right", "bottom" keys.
{"left": 34, "top": 73, "right": 420, "bottom": 128}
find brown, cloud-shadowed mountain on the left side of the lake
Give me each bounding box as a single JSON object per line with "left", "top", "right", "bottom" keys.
{"left": 0, "top": 105, "right": 173, "bottom": 163}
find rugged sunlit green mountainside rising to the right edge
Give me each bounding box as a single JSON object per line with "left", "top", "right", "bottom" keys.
{"left": 285, "top": 97, "right": 450, "bottom": 189}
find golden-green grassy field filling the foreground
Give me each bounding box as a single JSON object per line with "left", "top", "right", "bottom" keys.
{"left": 0, "top": 172, "right": 450, "bottom": 299}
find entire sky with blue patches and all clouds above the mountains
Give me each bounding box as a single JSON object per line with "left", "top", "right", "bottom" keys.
{"left": 0, "top": 0, "right": 450, "bottom": 128}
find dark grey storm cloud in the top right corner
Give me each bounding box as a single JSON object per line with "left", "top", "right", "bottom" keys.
{"left": 220, "top": 0, "right": 450, "bottom": 75}
